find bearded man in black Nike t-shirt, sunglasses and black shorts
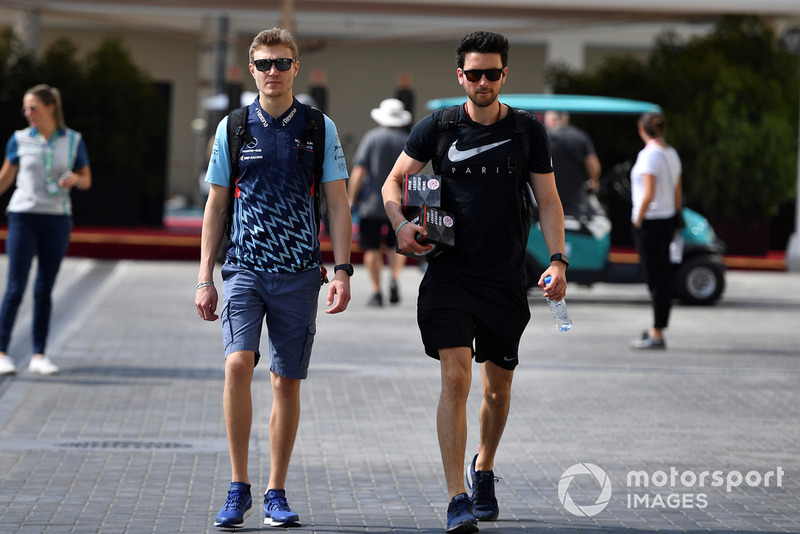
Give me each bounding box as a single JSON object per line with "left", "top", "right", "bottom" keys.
{"left": 383, "top": 31, "right": 568, "bottom": 532}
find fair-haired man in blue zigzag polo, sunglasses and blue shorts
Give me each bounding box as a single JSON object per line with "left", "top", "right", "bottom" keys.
{"left": 195, "top": 28, "right": 353, "bottom": 528}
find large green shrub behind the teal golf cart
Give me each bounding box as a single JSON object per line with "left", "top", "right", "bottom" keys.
{"left": 548, "top": 17, "right": 800, "bottom": 219}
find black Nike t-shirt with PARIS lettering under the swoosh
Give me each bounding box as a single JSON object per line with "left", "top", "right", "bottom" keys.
{"left": 404, "top": 107, "right": 553, "bottom": 287}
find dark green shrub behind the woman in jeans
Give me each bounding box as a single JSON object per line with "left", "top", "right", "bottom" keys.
{"left": 0, "top": 32, "right": 168, "bottom": 226}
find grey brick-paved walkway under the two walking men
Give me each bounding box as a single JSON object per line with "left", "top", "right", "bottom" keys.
{"left": 0, "top": 258, "right": 800, "bottom": 534}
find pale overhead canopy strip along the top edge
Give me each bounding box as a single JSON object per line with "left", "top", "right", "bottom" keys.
{"left": 0, "top": 0, "right": 800, "bottom": 43}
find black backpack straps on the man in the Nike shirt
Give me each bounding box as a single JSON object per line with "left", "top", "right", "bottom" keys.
{"left": 431, "top": 104, "right": 534, "bottom": 235}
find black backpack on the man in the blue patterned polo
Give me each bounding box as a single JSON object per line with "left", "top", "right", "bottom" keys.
{"left": 225, "top": 104, "right": 325, "bottom": 238}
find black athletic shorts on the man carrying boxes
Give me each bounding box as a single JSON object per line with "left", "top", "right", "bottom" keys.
{"left": 417, "top": 272, "right": 531, "bottom": 370}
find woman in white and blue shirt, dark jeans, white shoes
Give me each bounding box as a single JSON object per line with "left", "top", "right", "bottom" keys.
{"left": 0, "top": 85, "right": 92, "bottom": 375}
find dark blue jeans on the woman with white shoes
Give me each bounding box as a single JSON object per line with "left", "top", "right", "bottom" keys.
{"left": 0, "top": 213, "right": 72, "bottom": 354}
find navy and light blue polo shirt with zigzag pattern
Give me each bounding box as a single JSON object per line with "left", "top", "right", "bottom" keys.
{"left": 206, "top": 98, "right": 348, "bottom": 272}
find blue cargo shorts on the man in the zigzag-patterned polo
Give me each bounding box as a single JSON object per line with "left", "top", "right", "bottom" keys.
{"left": 222, "top": 263, "right": 322, "bottom": 379}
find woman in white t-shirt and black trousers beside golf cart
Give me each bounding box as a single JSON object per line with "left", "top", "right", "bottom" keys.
{"left": 631, "top": 112, "right": 682, "bottom": 349}
